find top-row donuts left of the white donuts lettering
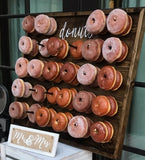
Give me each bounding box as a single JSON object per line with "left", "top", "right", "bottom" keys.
{"left": 22, "top": 14, "right": 57, "bottom": 35}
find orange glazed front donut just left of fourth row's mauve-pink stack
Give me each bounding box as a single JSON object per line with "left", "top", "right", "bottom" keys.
{"left": 56, "top": 88, "right": 72, "bottom": 108}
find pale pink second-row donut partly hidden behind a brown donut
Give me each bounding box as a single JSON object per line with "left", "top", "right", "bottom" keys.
{"left": 39, "top": 38, "right": 50, "bottom": 57}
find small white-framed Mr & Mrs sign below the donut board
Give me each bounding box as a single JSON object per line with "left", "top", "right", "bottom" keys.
{"left": 8, "top": 124, "right": 59, "bottom": 157}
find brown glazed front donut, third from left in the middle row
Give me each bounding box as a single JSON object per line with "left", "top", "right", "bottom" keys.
{"left": 43, "top": 61, "right": 59, "bottom": 81}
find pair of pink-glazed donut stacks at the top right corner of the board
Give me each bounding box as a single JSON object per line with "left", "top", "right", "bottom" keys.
{"left": 86, "top": 8, "right": 132, "bottom": 36}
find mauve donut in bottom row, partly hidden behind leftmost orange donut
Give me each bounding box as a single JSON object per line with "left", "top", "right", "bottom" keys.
{"left": 27, "top": 103, "right": 41, "bottom": 123}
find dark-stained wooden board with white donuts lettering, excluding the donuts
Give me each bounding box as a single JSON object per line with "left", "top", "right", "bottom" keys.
{"left": 12, "top": 8, "right": 145, "bottom": 159}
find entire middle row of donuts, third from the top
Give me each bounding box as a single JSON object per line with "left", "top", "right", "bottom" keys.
{"left": 15, "top": 57, "right": 123, "bottom": 91}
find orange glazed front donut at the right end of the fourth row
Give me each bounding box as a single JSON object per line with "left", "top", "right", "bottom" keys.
{"left": 91, "top": 95, "right": 111, "bottom": 116}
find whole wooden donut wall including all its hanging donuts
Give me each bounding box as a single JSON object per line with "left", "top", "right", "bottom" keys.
{"left": 9, "top": 8, "right": 145, "bottom": 159}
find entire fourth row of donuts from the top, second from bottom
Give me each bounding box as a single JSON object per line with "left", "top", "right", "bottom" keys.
{"left": 12, "top": 79, "right": 118, "bottom": 117}
